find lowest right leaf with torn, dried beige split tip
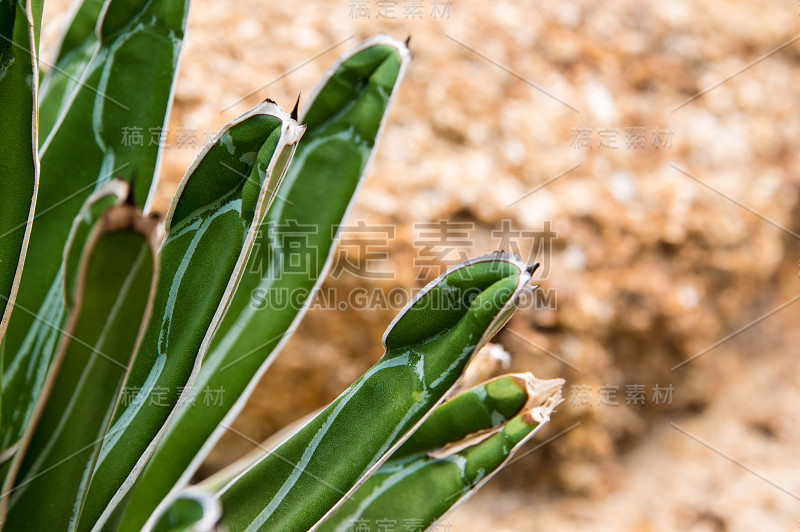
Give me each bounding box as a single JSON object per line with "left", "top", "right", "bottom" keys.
{"left": 318, "top": 373, "right": 564, "bottom": 532}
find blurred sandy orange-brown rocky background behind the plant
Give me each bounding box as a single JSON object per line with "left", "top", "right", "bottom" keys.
{"left": 43, "top": 0, "right": 800, "bottom": 532}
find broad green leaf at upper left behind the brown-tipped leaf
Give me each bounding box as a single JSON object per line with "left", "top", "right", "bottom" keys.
{"left": 0, "top": 0, "right": 188, "bottom": 462}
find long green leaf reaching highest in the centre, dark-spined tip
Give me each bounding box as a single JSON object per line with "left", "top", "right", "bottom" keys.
{"left": 122, "top": 35, "right": 409, "bottom": 531}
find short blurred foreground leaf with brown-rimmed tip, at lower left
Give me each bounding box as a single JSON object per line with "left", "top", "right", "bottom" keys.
{"left": 3, "top": 186, "right": 159, "bottom": 531}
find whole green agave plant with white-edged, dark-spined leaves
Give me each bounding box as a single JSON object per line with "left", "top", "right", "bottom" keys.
{"left": 0, "top": 0, "right": 562, "bottom": 531}
